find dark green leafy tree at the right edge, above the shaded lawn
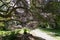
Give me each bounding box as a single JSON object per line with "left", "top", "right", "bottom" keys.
{"left": 44, "top": 2, "right": 60, "bottom": 28}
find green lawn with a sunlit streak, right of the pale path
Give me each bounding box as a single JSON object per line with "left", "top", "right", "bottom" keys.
{"left": 40, "top": 28, "right": 60, "bottom": 40}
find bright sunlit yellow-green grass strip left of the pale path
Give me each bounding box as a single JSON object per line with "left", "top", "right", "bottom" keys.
{"left": 0, "top": 28, "right": 30, "bottom": 36}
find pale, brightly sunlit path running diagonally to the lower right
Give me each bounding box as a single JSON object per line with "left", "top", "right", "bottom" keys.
{"left": 30, "top": 29, "right": 55, "bottom": 40}
